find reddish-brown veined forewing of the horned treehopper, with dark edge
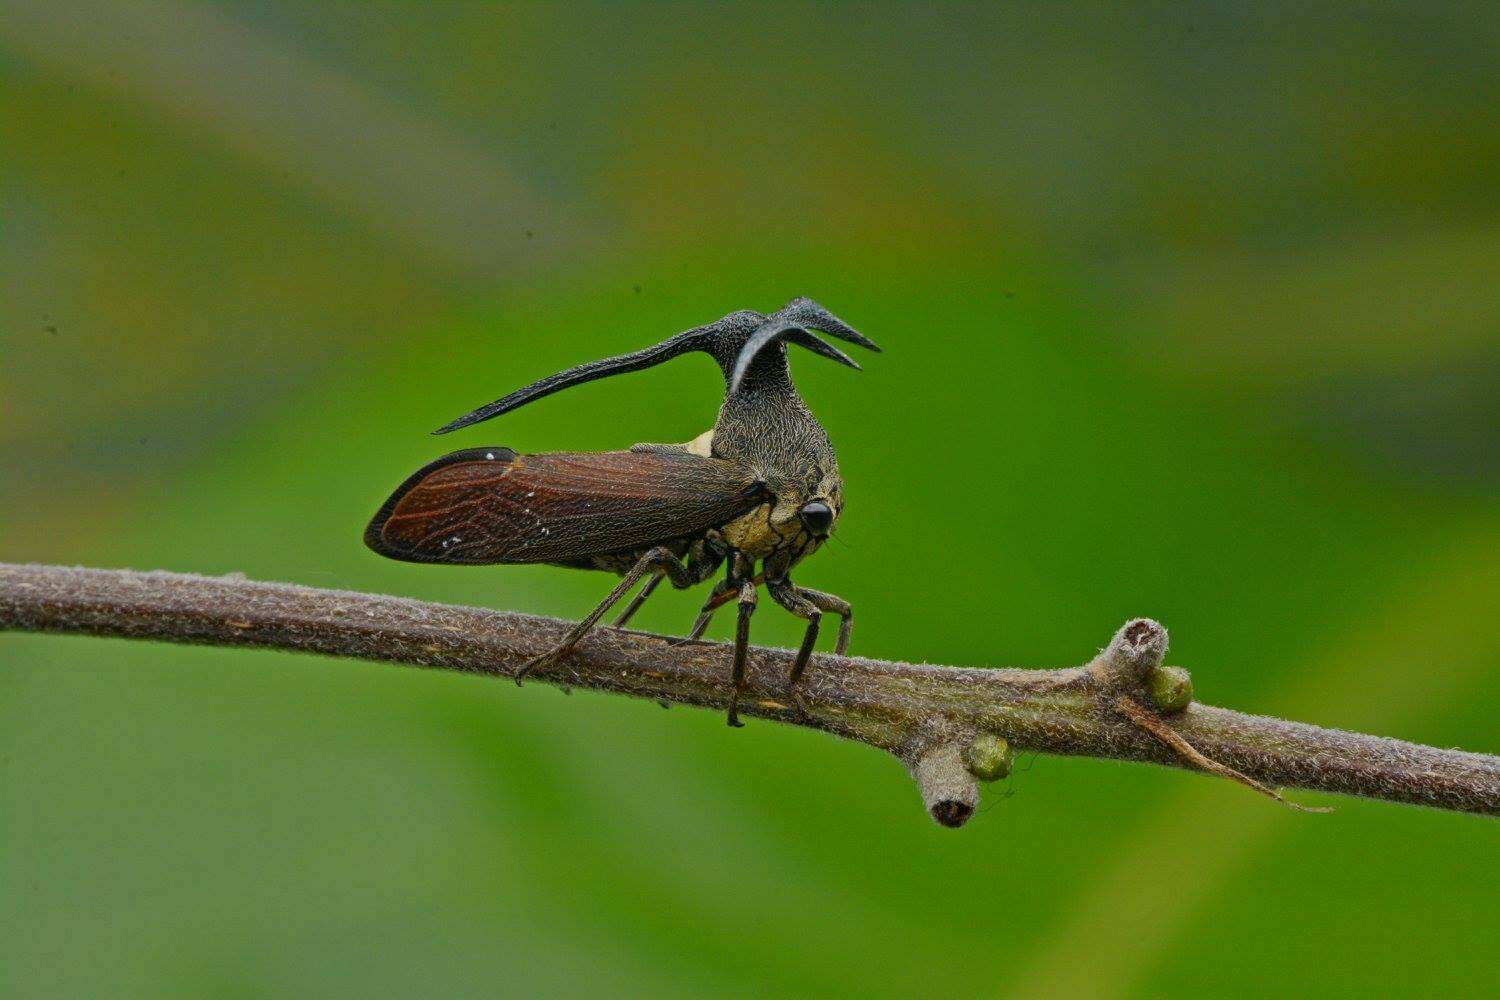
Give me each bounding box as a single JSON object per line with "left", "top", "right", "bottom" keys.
{"left": 365, "top": 448, "right": 765, "bottom": 564}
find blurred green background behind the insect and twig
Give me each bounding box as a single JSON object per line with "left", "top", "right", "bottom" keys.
{"left": 0, "top": 0, "right": 1500, "bottom": 997}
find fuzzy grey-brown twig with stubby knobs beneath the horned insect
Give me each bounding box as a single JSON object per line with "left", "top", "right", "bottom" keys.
{"left": 0, "top": 564, "right": 1500, "bottom": 826}
